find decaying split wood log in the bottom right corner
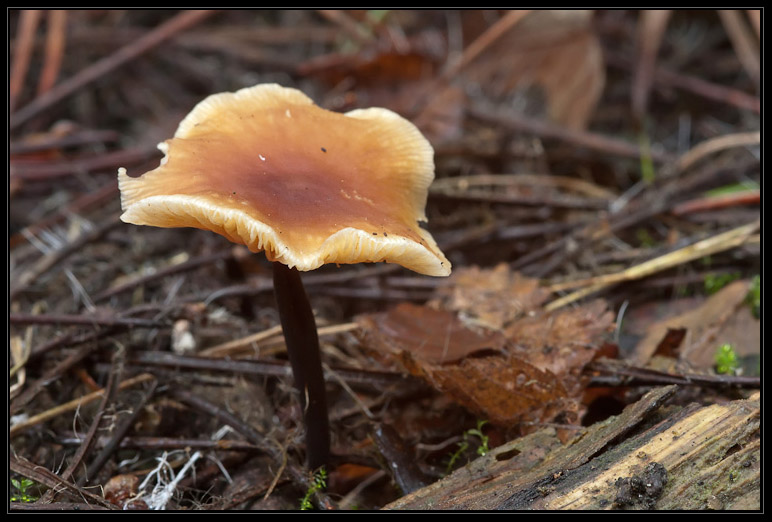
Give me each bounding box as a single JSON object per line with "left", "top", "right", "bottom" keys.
{"left": 386, "top": 386, "right": 761, "bottom": 510}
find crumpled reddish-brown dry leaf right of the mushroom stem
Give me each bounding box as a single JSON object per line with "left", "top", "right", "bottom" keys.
{"left": 359, "top": 265, "right": 613, "bottom": 431}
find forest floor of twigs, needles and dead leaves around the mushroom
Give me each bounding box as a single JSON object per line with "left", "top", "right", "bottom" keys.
{"left": 8, "top": 10, "right": 763, "bottom": 511}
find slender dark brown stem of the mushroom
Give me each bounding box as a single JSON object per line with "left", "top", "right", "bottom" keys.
{"left": 273, "top": 262, "right": 330, "bottom": 470}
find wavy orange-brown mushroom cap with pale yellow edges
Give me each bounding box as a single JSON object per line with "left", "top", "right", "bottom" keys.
{"left": 118, "top": 84, "right": 450, "bottom": 276}
